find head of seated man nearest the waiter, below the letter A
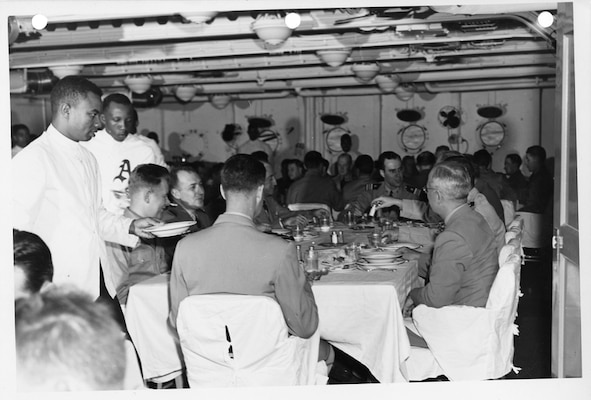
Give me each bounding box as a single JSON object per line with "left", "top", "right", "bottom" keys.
{"left": 127, "top": 164, "right": 170, "bottom": 218}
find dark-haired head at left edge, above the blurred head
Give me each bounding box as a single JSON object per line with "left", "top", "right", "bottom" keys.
{"left": 12, "top": 229, "right": 53, "bottom": 293}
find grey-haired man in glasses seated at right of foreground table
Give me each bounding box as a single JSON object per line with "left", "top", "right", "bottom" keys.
{"left": 402, "top": 160, "right": 499, "bottom": 347}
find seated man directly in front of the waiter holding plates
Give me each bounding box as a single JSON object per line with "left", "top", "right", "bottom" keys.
{"left": 107, "top": 164, "right": 170, "bottom": 305}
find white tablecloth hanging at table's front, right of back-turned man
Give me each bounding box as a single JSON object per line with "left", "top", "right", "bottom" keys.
{"left": 312, "top": 262, "right": 421, "bottom": 383}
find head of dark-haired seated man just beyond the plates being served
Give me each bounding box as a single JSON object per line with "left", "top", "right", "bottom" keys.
{"left": 170, "top": 165, "right": 205, "bottom": 214}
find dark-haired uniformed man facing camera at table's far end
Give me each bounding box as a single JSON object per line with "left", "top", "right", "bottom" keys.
{"left": 345, "top": 151, "right": 418, "bottom": 220}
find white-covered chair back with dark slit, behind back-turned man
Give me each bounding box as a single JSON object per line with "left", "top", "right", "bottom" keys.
{"left": 177, "top": 294, "right": 298, "bottom": 387}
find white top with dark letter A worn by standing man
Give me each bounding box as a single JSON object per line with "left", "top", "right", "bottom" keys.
{"left": 80, "top": 130, "right": 166, "bottom": 215}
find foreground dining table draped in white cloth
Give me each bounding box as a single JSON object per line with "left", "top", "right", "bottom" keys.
{"left": 125, "top": 223, "right": 435, "bottom": 383}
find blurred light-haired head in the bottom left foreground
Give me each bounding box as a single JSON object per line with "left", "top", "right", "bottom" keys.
{"left": 15, "top": 288, "right": 127, "bottom": 390}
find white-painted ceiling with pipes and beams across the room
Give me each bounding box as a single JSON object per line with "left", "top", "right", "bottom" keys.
{"left": 9, "top": 2, "right": 556, "bottom": 101}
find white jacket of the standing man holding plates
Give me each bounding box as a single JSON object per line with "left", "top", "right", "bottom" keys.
{"left": 11, "top": 125, "right": 138, "bottom": 298}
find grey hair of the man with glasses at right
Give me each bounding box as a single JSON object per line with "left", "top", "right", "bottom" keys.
{"left": 429, "top": 160, "right": 474, "bottom": 200}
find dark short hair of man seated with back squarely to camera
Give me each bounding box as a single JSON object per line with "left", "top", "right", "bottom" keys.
{"left": 221, "top": 154, "right": 267, "bottom": 192}
